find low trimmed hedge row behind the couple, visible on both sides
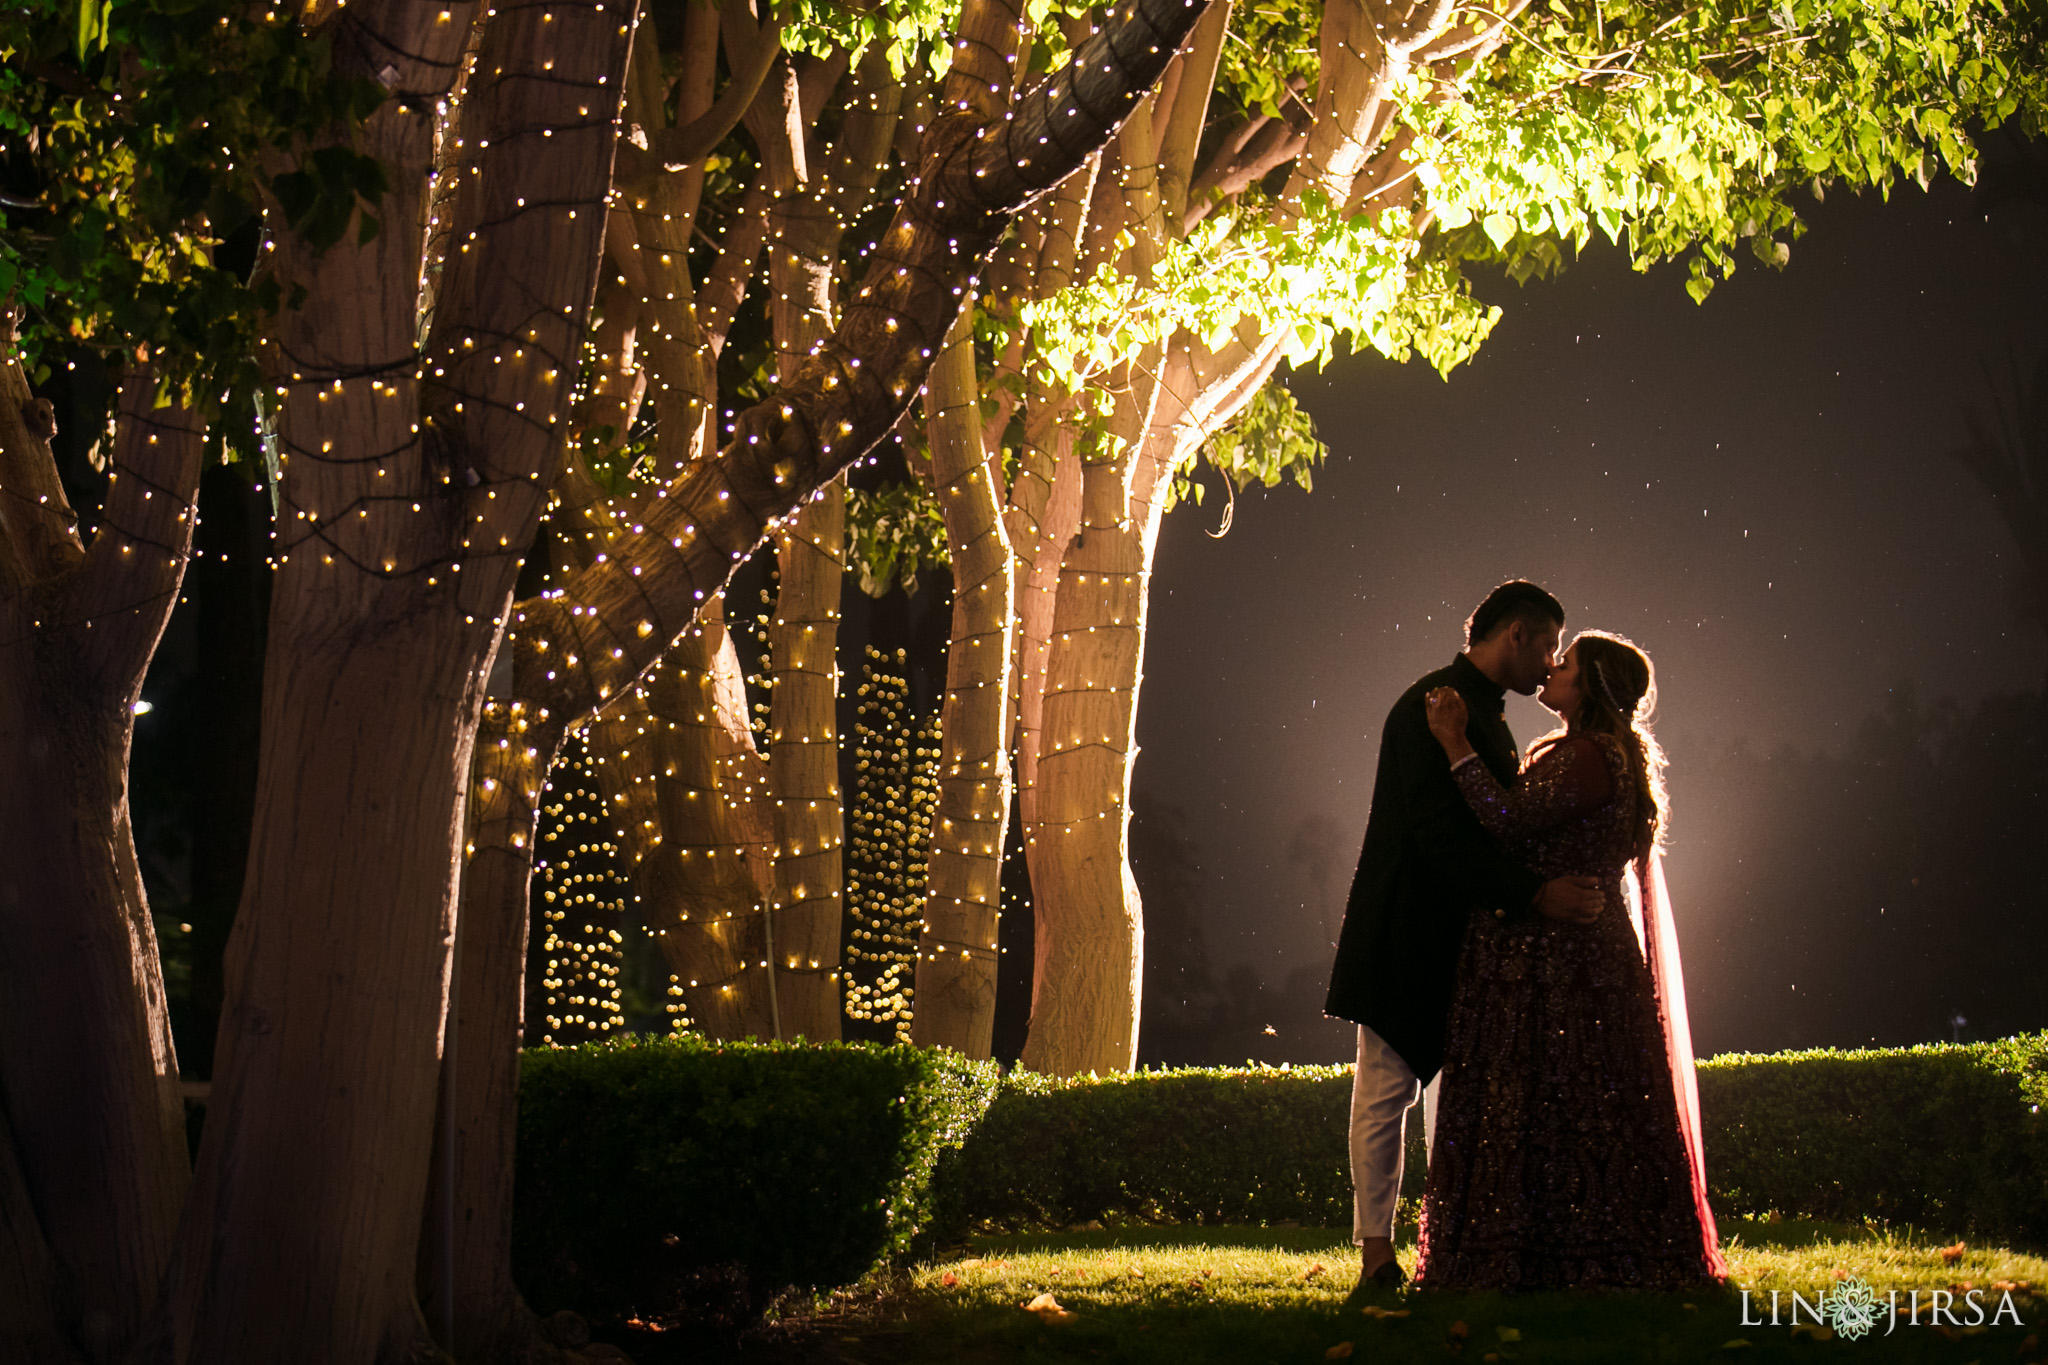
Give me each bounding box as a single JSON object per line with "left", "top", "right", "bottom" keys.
{"left": 934, "top": 1033, "right": 2048, "bottom": 1244}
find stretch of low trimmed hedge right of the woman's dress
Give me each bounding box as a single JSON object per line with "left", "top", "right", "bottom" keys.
{"left": 1700, "top": 1033, "right": 2048, "bottom": 1244}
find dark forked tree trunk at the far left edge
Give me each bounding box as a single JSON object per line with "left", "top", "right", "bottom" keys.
{"left": 0, "top": 358, "right": 203, "bottom": 1361}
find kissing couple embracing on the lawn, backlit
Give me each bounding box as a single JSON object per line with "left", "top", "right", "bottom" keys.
{"left": 1325, "top": 579, "right": 1726, "bottom": 1300}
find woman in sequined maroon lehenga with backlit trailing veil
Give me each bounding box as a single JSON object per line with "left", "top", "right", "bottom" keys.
{"left": 1415, "top": 632, "right": 1726, "bottom": 1289}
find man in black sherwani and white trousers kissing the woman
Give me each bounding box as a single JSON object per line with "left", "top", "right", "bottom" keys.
{"left": 1323, "top": 579, "right": 1602, "bottom": 1293}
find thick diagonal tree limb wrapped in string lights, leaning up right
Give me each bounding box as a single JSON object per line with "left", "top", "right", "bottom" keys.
{"left": 508, "top": 0, "right": 1206, "bottom": 714}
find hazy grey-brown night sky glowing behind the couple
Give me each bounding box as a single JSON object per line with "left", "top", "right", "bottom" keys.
{"left": 1133, "top": 170, "right": 2048, "bottom": 1060}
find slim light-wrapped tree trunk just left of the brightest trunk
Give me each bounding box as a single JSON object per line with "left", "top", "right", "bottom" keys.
{"left": 911, "top": 325, "right": 1016, "bottom": 1058}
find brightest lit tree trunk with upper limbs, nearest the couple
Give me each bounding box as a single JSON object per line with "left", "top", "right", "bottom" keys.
{"left": 1020, "top": 2, "right": 1505, "bottom": 1074}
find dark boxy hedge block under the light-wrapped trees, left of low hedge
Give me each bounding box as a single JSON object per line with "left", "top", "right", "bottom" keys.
{"left": 514, "top": 1038, "right": 997, "bottom": 1320}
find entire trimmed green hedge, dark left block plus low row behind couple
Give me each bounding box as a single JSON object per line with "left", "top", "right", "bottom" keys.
{"left": 514, "top": 1033, "right": 2048, "bottom": 1320}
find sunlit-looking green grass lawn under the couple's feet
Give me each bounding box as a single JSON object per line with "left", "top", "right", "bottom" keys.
{"left": 623, "top": 1222, "right": 2048, "bottom": 1365}
